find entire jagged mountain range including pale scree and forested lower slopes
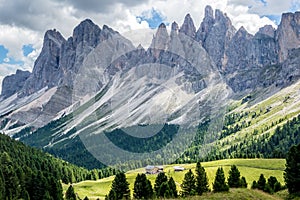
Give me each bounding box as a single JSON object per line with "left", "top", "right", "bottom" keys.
{"left": 0, "top": 6, "right": 300, "bottom": 168}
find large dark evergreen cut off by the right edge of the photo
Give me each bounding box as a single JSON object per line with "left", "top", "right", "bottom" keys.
{"left": 284, "top": 144, "right": 300, "bottom": 196}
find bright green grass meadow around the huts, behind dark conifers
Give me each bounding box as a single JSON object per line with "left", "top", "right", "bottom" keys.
{"left": 63, "top": 159, "right": 285, "bottom": 199}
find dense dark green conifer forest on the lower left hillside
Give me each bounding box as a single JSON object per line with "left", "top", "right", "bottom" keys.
{"left": 0, "top": 134, "right": 116, "bottom": 200}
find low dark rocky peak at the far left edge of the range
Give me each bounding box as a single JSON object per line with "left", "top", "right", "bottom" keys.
{"left": 1, "top": 69, "right": 30, "bottom": 98}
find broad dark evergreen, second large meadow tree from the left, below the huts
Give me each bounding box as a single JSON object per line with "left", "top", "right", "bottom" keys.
{"left": 133, "top": 174, "right": 153, "bottom": 199}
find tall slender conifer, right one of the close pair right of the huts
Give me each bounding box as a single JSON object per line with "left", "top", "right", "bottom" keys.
{"left": 196, "top": 162, "right": 209, "bottom": 195}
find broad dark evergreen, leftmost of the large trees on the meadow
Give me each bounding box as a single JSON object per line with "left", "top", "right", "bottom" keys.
{"left": 111, "top": 172, "right": 130, "bottom": 199}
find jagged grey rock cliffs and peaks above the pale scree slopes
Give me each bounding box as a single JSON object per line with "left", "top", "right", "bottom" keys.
{"left": 0, "top": 6, "right": 300, "bottom": 132}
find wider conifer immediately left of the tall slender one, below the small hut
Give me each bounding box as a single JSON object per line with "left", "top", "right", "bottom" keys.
{"left": 181, "top": 169, "right": 196, "bottom": 196}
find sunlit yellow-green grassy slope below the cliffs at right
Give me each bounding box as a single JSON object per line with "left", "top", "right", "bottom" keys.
{"left": 217, "top": 81, "right": 300, "bottom": 149}
